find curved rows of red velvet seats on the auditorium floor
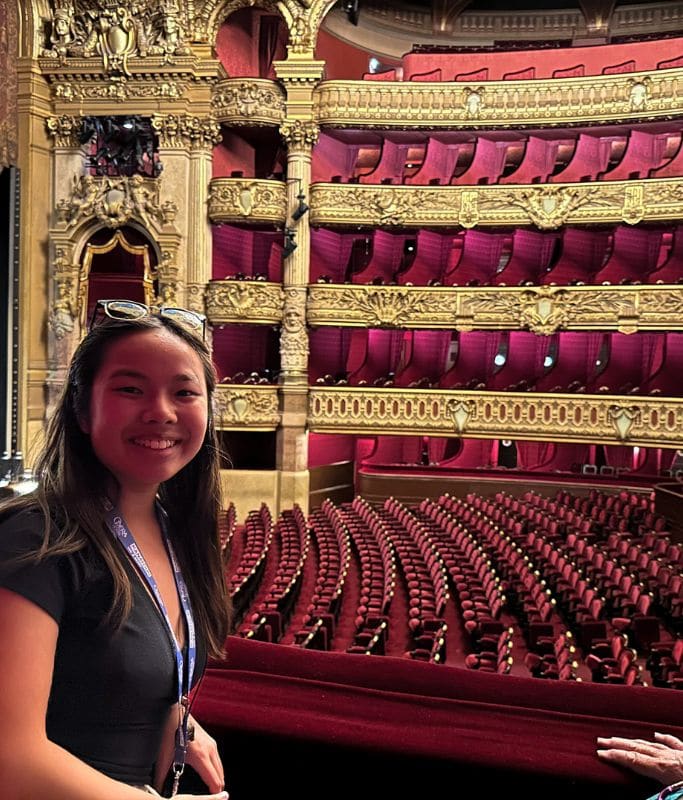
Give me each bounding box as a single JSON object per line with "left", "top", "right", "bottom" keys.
{"left": 226, "top": 491, "right": 683, "bottom": 686}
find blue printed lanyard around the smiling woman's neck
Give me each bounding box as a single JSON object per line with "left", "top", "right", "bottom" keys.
{"left": 107, "top": 506, "right": 197, "bottom": 794}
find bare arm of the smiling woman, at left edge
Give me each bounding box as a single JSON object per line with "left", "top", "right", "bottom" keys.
{"left": 0, "top": 588, "right": 230, "bottom": 800}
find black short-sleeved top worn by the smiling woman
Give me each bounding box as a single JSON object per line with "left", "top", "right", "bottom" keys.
{"left": 0, "top": 510, "right": 206, "bottom": 785}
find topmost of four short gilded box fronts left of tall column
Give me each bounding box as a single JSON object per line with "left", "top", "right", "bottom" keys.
{"left": 212, "top": 78, "right": 285, "bottom": 125}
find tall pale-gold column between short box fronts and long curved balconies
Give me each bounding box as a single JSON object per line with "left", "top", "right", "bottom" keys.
{"left": 275, "top": 61, "right": 323, "bottom": 509}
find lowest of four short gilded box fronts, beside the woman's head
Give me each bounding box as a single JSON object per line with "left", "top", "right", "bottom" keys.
{"left": 214, "top": 383, "right": 280, "bottom": 431}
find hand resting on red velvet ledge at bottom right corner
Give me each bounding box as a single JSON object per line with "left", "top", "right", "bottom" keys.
{"left": 598, "top": 733, "right": 683, "bottom": 786}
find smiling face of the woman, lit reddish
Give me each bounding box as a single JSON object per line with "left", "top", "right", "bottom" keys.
{"left": 81, "top": 328, "right": 208, "bottom": 504}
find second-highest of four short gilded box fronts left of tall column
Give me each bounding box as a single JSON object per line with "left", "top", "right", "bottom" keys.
{"left": 209, "top": 178, "right": 287, "bottom": 224}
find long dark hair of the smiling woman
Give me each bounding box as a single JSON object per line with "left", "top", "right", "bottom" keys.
{"left": 2, "top": 316, "right": 230, "bottom": 657}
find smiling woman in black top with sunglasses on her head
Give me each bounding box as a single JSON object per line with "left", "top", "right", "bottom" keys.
{"left": 0, "top": 304, "right": 228, "bottom": 800}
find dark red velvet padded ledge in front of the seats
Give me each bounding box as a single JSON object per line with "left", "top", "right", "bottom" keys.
{"left": 195, "top": 638, "right": 683, "bottom": 800}
